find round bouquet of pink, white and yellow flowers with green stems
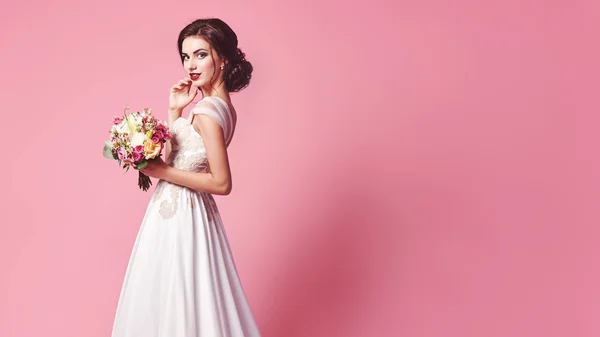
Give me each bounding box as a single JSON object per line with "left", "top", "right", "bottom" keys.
{"left": 104, "top": 107, "right": 172, "bottom": 191}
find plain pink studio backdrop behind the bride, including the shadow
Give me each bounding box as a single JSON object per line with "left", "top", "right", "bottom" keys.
{"left": 0, "top": 0, "right": 600, "bottom": 337}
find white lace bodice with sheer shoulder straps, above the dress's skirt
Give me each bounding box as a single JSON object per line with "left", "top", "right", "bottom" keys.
{"left": 165, "top": 96, "right": 236, "bottom": 172}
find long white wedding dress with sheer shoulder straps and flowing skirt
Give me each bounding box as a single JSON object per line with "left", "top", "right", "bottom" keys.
{"left": 112, "top": 96, "right": 260, "bottom": 337}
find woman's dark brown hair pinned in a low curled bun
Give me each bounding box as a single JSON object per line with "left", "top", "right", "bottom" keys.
{"left": 177, "top": 18, "right": 252, "bottom": 92}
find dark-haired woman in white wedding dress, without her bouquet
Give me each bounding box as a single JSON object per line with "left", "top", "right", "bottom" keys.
{"left": 112, "top": 19, "right": 260, "bottom": 337}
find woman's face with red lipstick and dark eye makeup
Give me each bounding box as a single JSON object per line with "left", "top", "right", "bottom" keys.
{"left": 181, "top": 36, "right": 222, "bottom": 88}
